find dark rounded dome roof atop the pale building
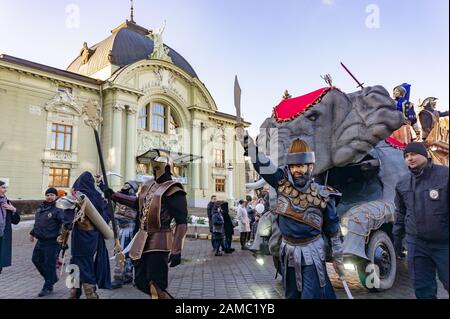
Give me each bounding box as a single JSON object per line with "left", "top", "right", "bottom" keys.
{"left": 67, "top": 20, "right": 197, "bottom": 77}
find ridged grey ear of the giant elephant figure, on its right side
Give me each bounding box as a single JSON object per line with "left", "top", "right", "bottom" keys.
{"left": 332, "top": 86, "right": 403, "bottom": 166}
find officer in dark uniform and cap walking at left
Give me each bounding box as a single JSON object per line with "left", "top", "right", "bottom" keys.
{"left": 30, "top": 187, "right": 70, "bottom": 297}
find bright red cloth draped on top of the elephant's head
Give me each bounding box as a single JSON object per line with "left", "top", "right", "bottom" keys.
{"left": 273, "top": 87, "right": 335, "bottom": 122}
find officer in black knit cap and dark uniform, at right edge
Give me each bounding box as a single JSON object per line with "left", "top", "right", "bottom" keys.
{"left": 393, "top": 142, "right": 449, "bottom": 299}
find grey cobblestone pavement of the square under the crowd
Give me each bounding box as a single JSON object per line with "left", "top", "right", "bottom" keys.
{"left": 0, "top": 221, "right": 448, "bottom": 299}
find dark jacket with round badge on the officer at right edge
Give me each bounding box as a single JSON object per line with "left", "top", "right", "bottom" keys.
{"left": 393, "top": 161, "right": 449, "bottom": 244}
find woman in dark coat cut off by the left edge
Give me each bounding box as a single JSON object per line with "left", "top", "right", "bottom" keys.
{"left": 0, "top": 181, "right": 20, "bottom": 273}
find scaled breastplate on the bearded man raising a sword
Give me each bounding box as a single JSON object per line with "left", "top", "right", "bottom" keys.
{"left": 276, "top": 179, "right": 329, "bottom": 231}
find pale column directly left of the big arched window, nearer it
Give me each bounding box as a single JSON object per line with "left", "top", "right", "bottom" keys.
{"left": 125, "top": 106, "right": 137, "bottom": 181}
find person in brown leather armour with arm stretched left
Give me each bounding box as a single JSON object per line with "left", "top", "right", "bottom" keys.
{"left": 112, "top": 151, "right": 188, "bottom": 299}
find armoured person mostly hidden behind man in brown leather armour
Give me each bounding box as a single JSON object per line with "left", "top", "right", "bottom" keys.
{"left": 111, "top": 181, "right": 139, "bottom": 289}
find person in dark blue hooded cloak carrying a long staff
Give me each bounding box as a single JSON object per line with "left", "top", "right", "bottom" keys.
{"left": 63, "top": 172, "right": 111, "bottom": 299}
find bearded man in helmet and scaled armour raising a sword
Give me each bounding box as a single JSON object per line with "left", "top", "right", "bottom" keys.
{"left": 237, "top": 127, "right": 344, "bottom": 299}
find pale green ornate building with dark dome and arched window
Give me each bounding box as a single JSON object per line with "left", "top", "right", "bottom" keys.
{"left": 0, "top": 20, "right": 250, "bottom": 207}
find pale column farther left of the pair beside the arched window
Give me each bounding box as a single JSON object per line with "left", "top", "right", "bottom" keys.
{"left": 110, "top": 104, "right": 125, "bottom": 189}
